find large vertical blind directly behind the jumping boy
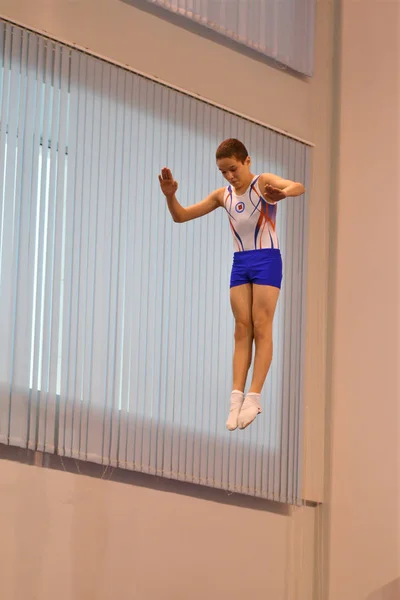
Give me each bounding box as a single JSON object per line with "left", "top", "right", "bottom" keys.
{"left": 0, "top": 23, "right": 308, "bottom": 503}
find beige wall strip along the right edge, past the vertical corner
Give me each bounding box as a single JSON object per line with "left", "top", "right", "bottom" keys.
{"left": 329, "top": 0, "right": 400, "bottom": 600}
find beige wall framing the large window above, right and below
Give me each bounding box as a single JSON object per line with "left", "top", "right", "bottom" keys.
{"left": 0, "top": 0, "right": 341, "bottom": 600}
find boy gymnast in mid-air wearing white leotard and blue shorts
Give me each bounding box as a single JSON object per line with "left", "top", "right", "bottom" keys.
{"left": 158, "top": 139, "right": 305, "bottom": 431}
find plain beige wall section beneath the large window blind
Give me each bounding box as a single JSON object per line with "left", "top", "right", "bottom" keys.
{"left": 0, "top": 460, "right": 318, "bottom": 600}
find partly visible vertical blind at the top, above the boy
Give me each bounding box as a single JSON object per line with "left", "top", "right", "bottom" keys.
{"left": 139, "top": 0, "right": 316, "bottom": 76}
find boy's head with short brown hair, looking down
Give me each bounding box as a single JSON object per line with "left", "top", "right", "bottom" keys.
{"left": 215, "top": 138, "right": 250, "bottom": 188}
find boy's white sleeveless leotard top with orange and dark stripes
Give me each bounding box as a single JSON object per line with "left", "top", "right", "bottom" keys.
{"left": 224, "top": 175, "right": 279, "bottom": 252}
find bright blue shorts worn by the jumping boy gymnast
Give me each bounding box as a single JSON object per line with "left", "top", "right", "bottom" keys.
{"left": 231, "top": 248, "right": 282, "bottom": 288}
